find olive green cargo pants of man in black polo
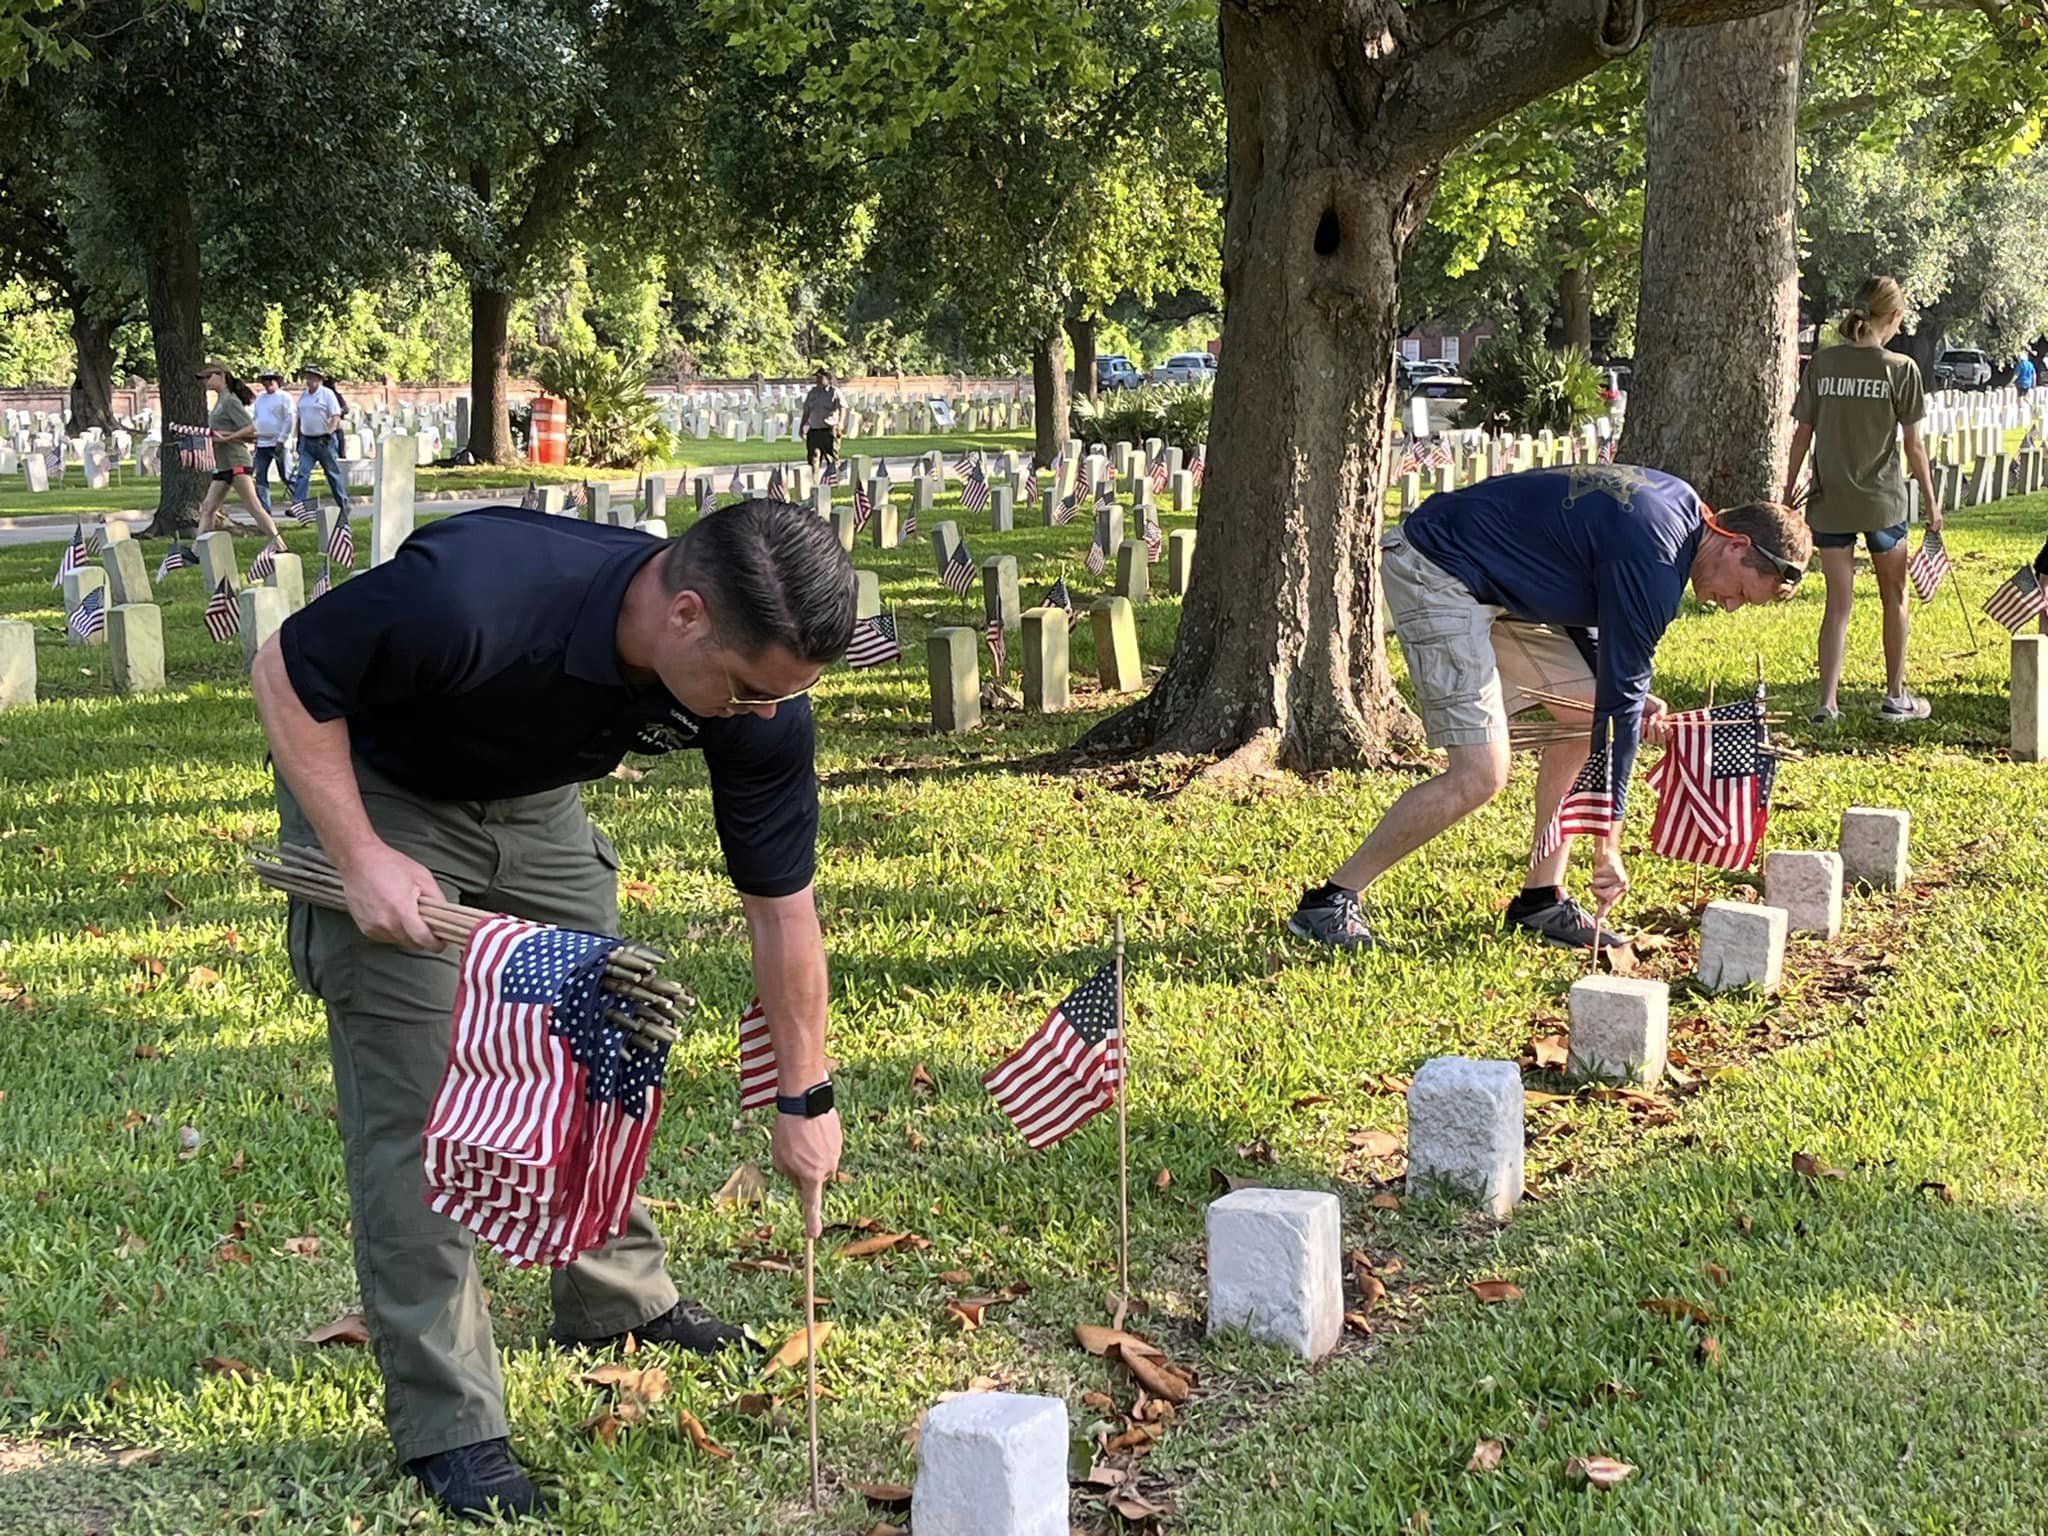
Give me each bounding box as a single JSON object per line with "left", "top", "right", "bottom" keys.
{"left": 276, "top": 762, "right": 676, "bottom": 1460}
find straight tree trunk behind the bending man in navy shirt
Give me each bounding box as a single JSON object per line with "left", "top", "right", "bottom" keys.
{"left": 1620, "top": 0, "right": 1812, "bottom": 506}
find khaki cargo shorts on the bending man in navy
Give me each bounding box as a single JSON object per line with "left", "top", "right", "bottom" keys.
{"left": 1380, "top": 530, "right": 1593, "bottom": 748}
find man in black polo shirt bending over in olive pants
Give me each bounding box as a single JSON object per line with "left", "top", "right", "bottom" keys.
{"left": 252, "top": 502, "right": 854, "bottom": 1513}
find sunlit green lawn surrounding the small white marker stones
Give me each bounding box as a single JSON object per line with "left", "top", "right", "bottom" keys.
{"left": 0, "top": 481, "right": 2048, "bottom": 1536}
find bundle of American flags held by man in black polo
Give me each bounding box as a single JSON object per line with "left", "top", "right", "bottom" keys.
{"left": 420, "top": 918, "right": 668, "bottom": 1266}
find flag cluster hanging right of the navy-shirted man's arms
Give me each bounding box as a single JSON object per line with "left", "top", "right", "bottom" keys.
{"left": 1647, "top": 690, "right": 1778, "bottom": 870}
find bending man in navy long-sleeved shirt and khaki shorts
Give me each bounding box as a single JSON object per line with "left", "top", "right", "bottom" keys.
{"left": 1288, "top": 465, "right": 1812, "bottom": 948}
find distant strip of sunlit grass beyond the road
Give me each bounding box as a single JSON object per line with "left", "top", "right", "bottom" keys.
{"left": 0, "top": 432, "right": 1032, "bottom": 518}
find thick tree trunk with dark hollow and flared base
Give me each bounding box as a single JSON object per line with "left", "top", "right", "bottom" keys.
{"left": 1090, "top": 6, "right": 1430, "bottom": 768}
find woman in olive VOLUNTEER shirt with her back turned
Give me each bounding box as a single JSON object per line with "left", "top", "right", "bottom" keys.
{"left": 1786, "top": 276, "right": 1942, "bottom": 725}
